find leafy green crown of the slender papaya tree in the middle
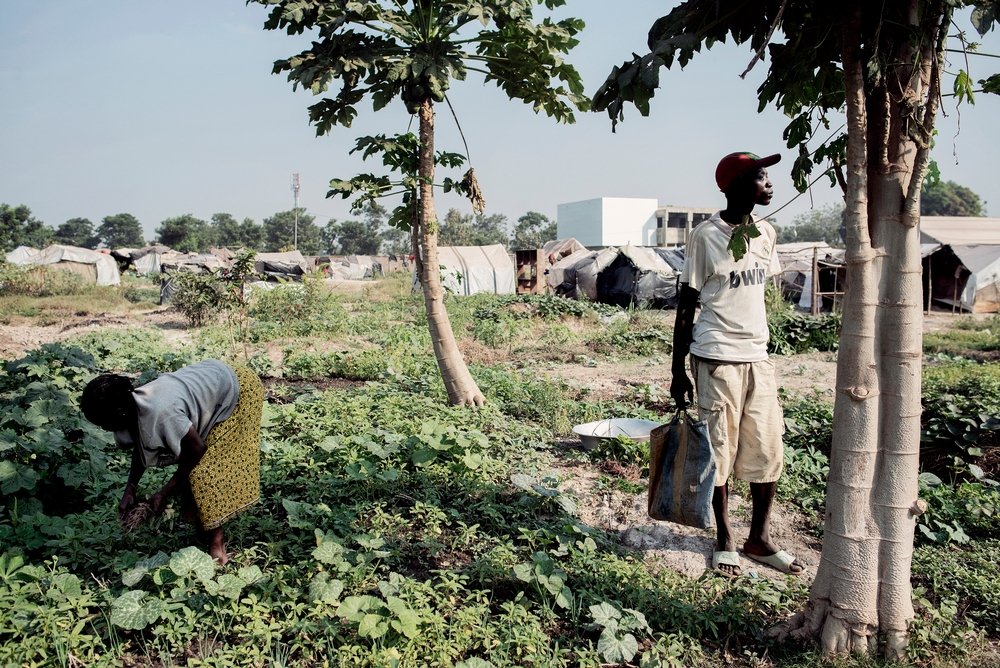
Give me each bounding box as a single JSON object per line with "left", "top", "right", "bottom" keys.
{"left": 250, "top": 0, "right": 588, "bottom": 135}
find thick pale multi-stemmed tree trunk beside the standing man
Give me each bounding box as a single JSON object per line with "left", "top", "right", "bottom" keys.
{"left": 778, "top": 0, "right": 950, "bottom": 659}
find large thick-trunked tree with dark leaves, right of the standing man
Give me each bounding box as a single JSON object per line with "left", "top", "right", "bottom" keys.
{"left": 594, "top": 0, "right": 1000, "bottom": 657}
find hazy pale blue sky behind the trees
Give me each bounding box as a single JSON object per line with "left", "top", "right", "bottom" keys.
{"left": 0, "top": 0, "right": 1000, "bottom": 237}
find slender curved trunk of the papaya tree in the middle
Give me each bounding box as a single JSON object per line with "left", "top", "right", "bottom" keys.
{"left": 417, "top": 100, "right": 486, "bottom": 406}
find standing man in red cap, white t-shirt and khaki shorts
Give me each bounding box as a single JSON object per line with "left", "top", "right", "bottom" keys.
{"left": 670, "top": 151, "right": 803, "bottom": 576}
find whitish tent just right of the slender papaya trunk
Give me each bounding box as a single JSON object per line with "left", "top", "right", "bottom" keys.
{"left": 438, "top": 244, "right": 514, "bottom": 295}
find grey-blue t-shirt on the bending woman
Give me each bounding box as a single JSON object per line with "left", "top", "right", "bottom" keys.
{"left": 115, "top": 360, "right": 240, "bottom": 467}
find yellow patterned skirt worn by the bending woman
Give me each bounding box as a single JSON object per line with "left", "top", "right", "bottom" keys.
{"left": 188, "top": 366, "right": 264, "bottom": 530}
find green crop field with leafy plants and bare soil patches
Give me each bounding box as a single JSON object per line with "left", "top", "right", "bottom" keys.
{"left": 0, "top": 266, "right": 1000, "bottom": 668}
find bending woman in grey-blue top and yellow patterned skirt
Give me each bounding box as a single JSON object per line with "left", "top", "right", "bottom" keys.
{"left": 80, "top": 360, "right": 264, "bottom": 564}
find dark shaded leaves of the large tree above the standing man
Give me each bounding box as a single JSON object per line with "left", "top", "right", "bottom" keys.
{"left": 593, "top": 0, "right": 1000, "bottom": 192}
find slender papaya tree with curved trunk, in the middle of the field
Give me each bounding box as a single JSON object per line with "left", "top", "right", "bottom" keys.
{"left": 248, "top": 0, "right": 588, "bottom": 405}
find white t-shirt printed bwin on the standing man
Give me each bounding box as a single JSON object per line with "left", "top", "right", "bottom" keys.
{"left": 681, "top": 213, "right": 781, "bottom": 362}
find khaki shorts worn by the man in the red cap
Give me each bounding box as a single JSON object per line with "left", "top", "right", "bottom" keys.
{"left": 691, "top": 355, "right": 785, "bottom": 487}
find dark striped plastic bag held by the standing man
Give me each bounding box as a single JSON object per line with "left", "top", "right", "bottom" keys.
{"left": 648, "top": 411, "right": 715, "bottom": 529}
